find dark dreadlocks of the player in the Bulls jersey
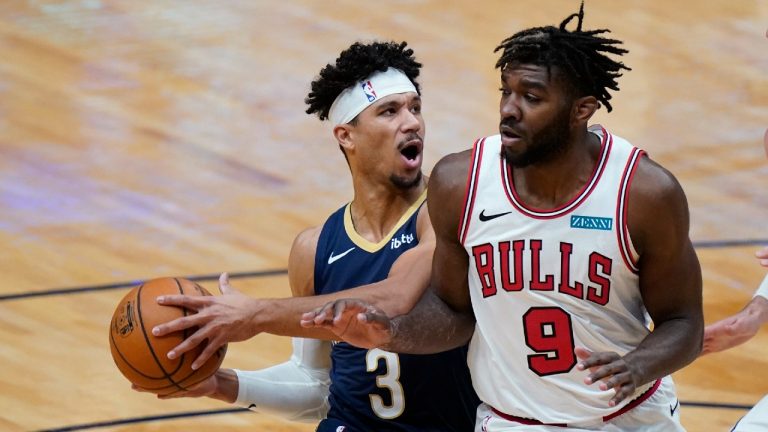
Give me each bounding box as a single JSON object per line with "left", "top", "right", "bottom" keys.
{"left": 493, "top": 1, "right": 631, "bottom": 112}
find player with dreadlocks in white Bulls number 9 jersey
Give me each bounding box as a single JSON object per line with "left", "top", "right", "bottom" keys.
{"left": 303, "top": 5, "right": 703, "bottom": 432}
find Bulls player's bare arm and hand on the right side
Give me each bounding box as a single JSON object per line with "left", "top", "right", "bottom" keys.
{"left": 577, "top": 158, "right": 704, "bottom": 405}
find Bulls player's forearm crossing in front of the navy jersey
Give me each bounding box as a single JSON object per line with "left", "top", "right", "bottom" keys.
{"left": 382, "top": 290, "right": 475, "bottom": 354}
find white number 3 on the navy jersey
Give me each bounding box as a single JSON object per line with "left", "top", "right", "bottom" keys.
{"left": 365, "top": 348, "right": 405, "bottom": 420}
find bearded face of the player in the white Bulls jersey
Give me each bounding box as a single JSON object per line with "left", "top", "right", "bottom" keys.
{"left": 499, "top": 64, "right": 572, "bottom": 167}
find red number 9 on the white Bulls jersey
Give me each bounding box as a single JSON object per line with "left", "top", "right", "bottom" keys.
{"left": 523, "top": 307, "right": 576, "bottom": 376}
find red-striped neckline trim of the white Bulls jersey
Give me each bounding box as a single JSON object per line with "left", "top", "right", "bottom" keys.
{"left": 501, "top": 126, "right": 613, "bottom": 219}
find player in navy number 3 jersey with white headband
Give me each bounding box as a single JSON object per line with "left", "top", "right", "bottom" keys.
{"left": 137, "top": 42, "right": 479, "bottom": 432}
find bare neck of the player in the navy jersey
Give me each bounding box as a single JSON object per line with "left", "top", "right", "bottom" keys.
{"left": 350, "top": 178, "right": 427, "bottom": 243}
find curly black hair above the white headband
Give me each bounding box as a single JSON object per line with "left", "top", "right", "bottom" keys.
{"left": 304, "top": 42, "right": 421, "bottom": 120}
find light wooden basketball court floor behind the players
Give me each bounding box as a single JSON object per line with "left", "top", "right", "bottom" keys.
{"left": 0, "top": 0, "right": 768, "bottom": 431}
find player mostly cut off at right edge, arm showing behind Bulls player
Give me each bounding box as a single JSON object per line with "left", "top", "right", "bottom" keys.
{"left": 701, "top": 129, "right": 768, "bottom": 432}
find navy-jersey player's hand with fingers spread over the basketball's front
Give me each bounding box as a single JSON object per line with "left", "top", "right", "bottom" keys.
{"left": 152, "top": 273, "right": 258, "bottom": 369}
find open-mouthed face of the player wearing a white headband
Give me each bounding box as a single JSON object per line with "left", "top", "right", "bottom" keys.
{"left": 355, "top": 92, "right": 425, "bottom": 189}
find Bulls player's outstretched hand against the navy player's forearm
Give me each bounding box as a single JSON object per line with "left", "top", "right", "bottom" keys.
{"left": 301, "top": 299, "right": 393, "bottom": 349}
